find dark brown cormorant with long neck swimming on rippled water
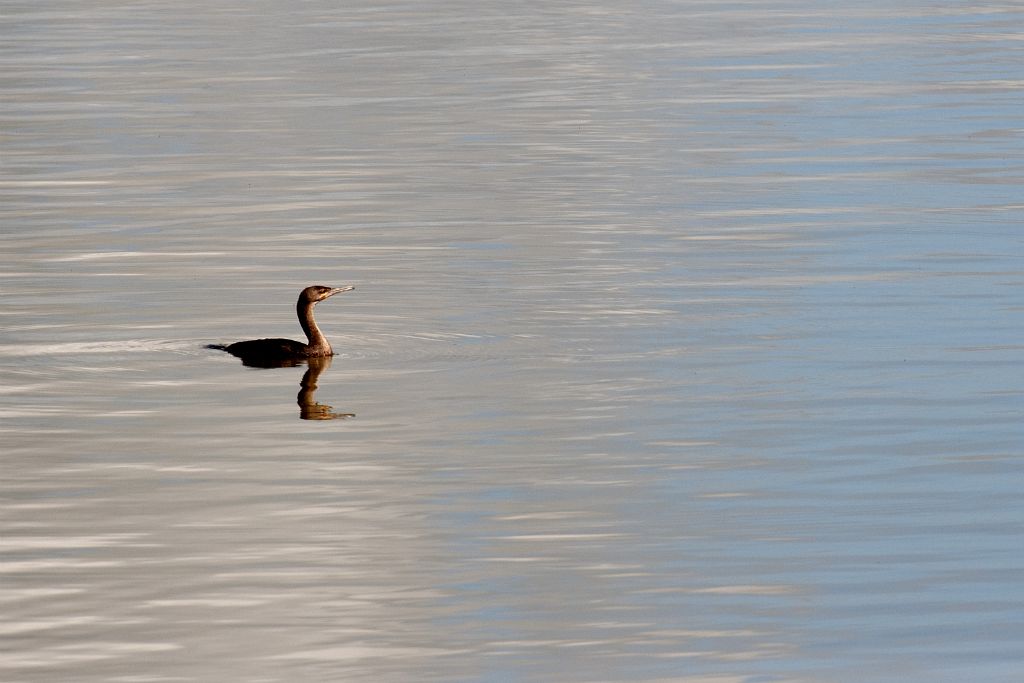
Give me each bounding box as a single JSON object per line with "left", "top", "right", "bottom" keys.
{"left": 207, "top": 285, "right": 355, "bottom": 368}
